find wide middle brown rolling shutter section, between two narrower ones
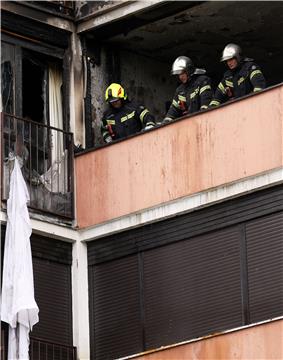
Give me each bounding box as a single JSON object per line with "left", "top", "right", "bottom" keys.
{"left": 144, "top": 226, "right": 242, "bottom": 349}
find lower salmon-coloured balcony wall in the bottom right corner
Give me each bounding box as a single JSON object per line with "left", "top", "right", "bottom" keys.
{"left": 134, "top": 320, "right": 283, "bottom": 360}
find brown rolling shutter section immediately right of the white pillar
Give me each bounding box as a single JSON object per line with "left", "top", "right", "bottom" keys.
{"left": 89, "top": 255, "right": 143, "bottom": 360}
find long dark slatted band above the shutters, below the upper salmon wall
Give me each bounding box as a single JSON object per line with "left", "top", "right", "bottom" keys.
{"left": 88, "top": 185, "right": 283, "bottom": 264}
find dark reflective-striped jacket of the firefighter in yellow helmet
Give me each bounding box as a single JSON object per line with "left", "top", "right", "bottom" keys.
{"left": 101, "top": 100, "right": 155, "bottom": 141}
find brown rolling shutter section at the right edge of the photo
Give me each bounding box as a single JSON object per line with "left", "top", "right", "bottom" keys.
{"left": 246, "top": 212, "right": 283, "bottom": 322}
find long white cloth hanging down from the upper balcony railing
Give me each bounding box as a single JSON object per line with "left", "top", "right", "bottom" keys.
{"left": 1, "top": 158, "right": 39, "bottom": 360}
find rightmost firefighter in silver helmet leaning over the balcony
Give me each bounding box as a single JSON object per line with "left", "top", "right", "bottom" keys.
{"left": 209, "top": 44, "right": 266, "bottom": 107}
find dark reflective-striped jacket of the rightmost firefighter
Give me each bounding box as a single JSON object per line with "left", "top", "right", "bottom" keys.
{"left": 209, "top": 58, "right": 266, "bottom": 107}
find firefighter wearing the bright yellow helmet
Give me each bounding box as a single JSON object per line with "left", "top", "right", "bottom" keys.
{"left": 101, "top": 83, "right": 155, "bottom": 143}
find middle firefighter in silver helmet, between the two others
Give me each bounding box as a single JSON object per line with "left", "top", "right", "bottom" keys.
{"left": 163, "top": 56, "right": 212, "bottom": 122}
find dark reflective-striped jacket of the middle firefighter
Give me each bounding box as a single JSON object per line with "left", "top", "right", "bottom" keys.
{"left": 164, "top": 70, "right": 212, "bottom": 121}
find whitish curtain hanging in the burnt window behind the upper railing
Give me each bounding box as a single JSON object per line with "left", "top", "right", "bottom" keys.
{"left": 41, "top": 64, "right": 68, "bottom": 193}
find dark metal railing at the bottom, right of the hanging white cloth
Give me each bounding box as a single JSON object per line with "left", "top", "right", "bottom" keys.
{"left": 29, "top": 337, "right": 77, "bottom": 360}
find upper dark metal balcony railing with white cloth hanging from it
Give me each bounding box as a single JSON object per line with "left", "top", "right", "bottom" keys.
{"left": 1, "top": 114, "right": 74, "bottom": 218}
